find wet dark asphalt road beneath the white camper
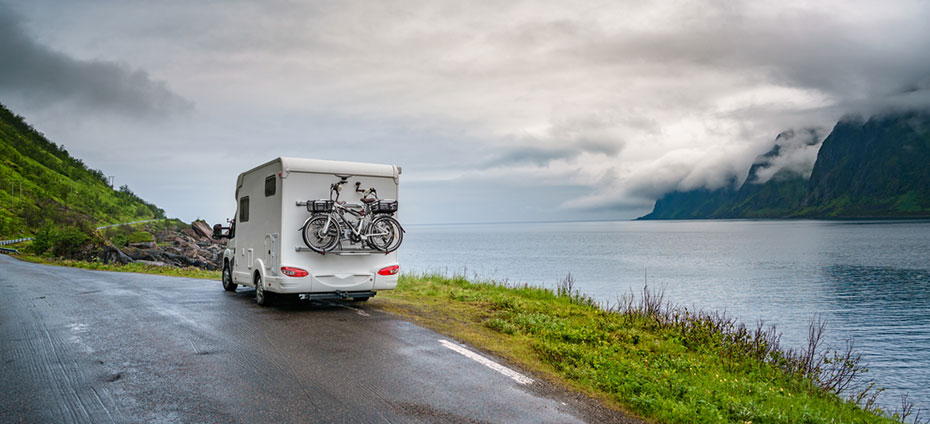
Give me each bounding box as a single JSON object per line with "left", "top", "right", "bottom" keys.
{"left": 0, "top": 255, "right": 608, "bottom": 423}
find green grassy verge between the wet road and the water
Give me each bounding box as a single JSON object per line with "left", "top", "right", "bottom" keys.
{"left": 374, "top": 275, "right": 893, "bottom": 423}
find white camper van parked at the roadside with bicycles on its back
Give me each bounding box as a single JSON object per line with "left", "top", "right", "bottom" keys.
{"left": 214, "top": 157, "right": 403, "bottom": 306}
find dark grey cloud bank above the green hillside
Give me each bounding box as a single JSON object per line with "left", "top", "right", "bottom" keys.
{"left": 0, "top": 4, "right": 192, "bottom": 117}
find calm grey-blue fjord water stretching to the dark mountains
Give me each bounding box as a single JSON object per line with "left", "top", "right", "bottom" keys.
{"left": 400, "top": 220, "right": 930, "bottom": 410}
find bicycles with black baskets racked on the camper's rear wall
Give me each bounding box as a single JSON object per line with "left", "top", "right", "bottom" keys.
{"left": 300, "top": 175, "right": 404, "bottom": 254}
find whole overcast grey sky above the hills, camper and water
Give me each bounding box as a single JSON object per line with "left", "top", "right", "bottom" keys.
{"left": 0, "top": 0, "right": 930, "bottom": 223}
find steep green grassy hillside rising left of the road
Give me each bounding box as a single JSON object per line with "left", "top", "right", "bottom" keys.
{"left": 0, "top": 104, "right": 165, "bottom": 240}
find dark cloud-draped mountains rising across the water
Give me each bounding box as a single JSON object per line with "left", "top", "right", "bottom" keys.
{"left": 640, "top": 112, "right": 930, "bottom": 219}
